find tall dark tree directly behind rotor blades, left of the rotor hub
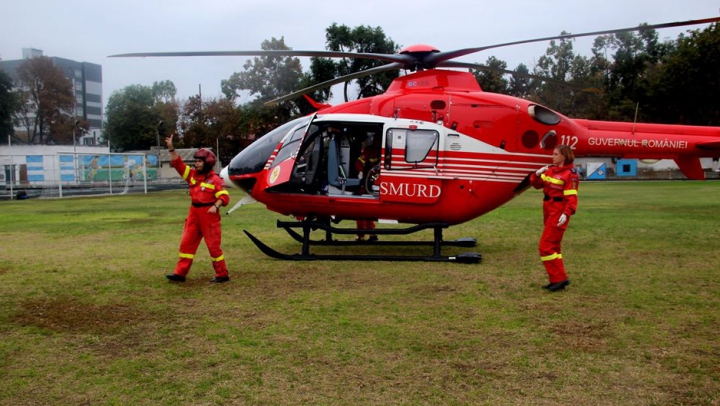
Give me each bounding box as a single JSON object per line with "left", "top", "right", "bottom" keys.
{"left": 320, "top": 23, "right": 400, "bottom": 102}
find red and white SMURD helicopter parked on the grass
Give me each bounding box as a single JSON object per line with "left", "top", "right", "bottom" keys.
{"left": 116, "top": 18, "right": 720, "bottom": 263}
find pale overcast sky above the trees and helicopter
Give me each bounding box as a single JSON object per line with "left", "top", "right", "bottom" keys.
{"left": 0, "top": 0, "right": 720, "bottom": 108}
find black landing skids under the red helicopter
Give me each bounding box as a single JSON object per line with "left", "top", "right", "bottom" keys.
{"left": 243, "top": 221, "right": 482, "bottom": 263}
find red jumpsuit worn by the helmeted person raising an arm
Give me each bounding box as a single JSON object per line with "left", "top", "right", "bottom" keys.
{"left": 170, "top": 157, "right": 230, "bottom": 277}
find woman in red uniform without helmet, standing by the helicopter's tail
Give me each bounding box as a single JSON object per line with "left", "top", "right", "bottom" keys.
{"left": 530, "top": 145, "right": 579, "bottom": 292}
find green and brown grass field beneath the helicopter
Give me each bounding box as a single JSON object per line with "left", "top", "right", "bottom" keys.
{"left": 0, "top": 181, "right": 720, "bottom": 405}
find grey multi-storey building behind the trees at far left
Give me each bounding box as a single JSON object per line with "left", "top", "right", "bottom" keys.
{"left": 0, "top": 48, "right": 103, "bottom": 146}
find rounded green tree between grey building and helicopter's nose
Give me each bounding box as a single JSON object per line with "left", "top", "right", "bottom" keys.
{"left": 104, "top": 85, "right": 170, "bottom": 152}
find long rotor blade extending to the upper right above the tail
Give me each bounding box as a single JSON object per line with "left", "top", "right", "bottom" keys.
{"left": 425, "top": 17, "right": 720, "bottom": 67}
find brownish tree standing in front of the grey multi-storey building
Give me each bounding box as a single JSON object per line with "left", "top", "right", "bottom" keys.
{"left": 15, "top": 56, "right": 75, "bottom": 144}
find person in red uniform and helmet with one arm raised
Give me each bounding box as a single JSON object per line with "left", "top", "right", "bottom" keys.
{"left": 165, "top": 135, "right": 230, "bottom": 283}
